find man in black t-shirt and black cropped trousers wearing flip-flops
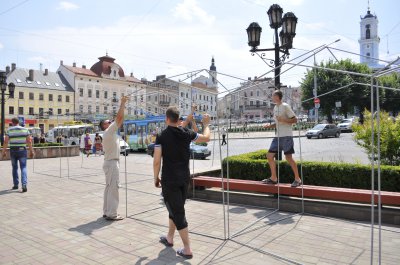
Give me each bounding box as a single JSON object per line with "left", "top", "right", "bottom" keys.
{"left": 153, "top": 107, "right": 211, "bottom": 259}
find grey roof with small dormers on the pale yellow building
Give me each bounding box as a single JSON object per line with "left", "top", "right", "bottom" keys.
{"left": 7, "top": 68, "right": 74, "bottom": 92}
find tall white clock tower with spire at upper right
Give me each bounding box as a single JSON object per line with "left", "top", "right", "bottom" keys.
{"left": 358, "top": 4, "right": 380, "bottom": 68}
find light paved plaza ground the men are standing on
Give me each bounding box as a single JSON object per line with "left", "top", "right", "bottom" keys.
{"left": 0, "top": 155, "right": 400, "bottom": 264}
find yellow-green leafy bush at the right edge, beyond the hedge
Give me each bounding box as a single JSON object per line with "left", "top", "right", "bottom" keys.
{"left": 353, "top": 110, "right": 400, "bottom": 166}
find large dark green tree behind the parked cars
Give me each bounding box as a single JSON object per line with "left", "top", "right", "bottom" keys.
{"left": 301, "top": 59, "right": 371, "bottom": 122}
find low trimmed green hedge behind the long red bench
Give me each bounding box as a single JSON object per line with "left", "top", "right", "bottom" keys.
{"left": 223, "top": 150, "right": 400, "bottom": 192}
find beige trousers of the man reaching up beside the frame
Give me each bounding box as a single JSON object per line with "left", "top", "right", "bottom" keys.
{"left": 103, "top": 160, "right": 119, "bottom": 217}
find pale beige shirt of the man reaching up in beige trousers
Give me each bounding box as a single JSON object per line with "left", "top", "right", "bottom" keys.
{"left": 103, "top": 121, "right": 121, "bottom": 160}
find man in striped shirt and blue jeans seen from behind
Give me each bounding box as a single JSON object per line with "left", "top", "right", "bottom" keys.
{"left": 3, "top": 118, "right": 35, "bottom": 192}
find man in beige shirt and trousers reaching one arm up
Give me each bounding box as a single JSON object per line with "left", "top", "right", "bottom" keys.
{"left": 99, "top": 96, "right": 129, "bottom": 221}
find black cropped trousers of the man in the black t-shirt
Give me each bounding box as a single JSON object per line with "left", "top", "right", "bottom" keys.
{"left": 161, "top": 180, "right": 189, "bottom": 230}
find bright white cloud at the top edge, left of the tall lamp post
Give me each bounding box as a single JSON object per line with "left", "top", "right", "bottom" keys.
{"left": 173, "top": 0, "right": 215, "bottom": 25}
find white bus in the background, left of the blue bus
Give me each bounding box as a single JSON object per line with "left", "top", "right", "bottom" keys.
{"left": 46, "top": 124, "right": 94, "bottom": 145}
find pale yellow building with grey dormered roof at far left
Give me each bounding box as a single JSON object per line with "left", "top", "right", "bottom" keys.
{"left": 5, "top": 64, "right": 74, "bottom": 132}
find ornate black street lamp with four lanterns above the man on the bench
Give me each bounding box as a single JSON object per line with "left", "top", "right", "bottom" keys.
{"left": 246, "top": 4, "right": 297, "bottom": 89}
